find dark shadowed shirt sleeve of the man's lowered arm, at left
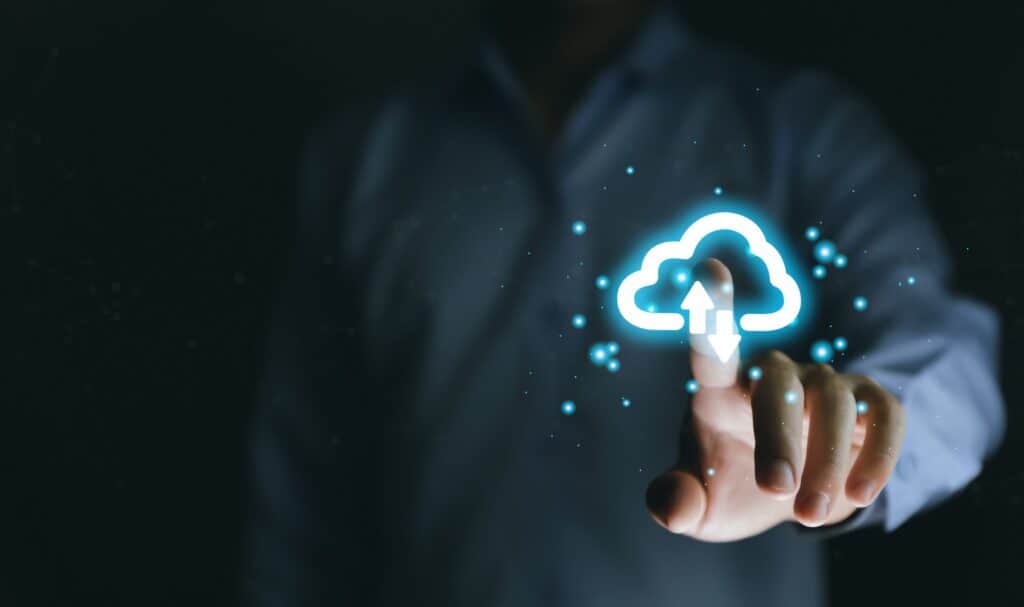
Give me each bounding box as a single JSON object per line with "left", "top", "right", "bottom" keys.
{"left": 242, "top": 111, "right": 374, "bottom": 607}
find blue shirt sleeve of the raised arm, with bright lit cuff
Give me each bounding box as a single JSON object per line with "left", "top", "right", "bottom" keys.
{"left": 788, "top": 77, "right": 1005, "bottom": 530}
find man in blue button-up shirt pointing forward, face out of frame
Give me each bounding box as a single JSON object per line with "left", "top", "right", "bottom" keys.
{"left": 247, "top": 1, "right": 1004, "bottom": 607}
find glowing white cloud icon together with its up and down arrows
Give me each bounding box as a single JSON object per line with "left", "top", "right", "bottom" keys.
{"left": 616, "top": 212, "right": 801, "bottom": 360}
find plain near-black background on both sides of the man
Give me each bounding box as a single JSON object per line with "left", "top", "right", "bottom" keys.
{"left": 0, "top": 0, "right": 1024, "bottom": 606}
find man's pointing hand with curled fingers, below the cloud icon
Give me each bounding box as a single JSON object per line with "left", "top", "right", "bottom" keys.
{"left": 647, "top": 259, "right": 905, "bottom": 541}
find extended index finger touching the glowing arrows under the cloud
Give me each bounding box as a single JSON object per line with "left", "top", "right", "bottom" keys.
{"left": 682, "top": 257, "right": 739, "bottom": 387}
